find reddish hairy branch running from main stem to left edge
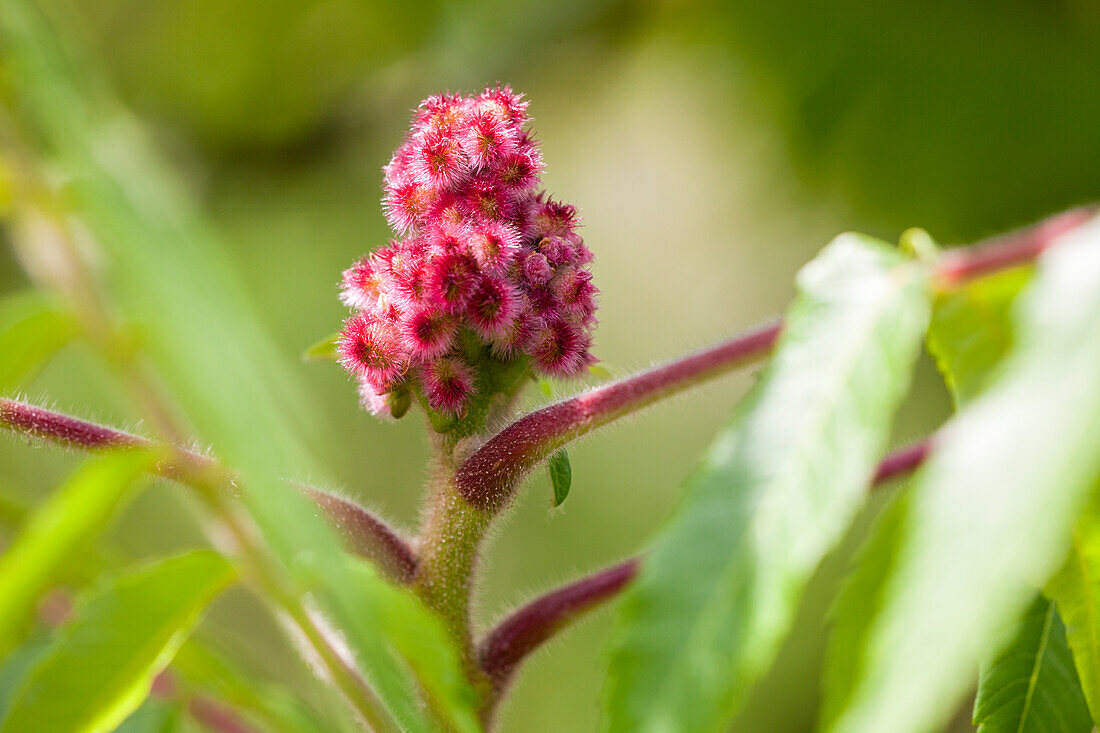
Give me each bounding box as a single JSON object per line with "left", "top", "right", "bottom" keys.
{"left": 0, "top": 398, "right": 417, "bottom": 582}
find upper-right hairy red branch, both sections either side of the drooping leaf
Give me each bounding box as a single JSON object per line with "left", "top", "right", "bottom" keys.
{"left": 455, "top": 208, "right": 1096, "bottom": 513}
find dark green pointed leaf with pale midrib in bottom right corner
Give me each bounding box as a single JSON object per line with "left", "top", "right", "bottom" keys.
{"left": 974, "top": 595, "right": 1092, "bottom": 733}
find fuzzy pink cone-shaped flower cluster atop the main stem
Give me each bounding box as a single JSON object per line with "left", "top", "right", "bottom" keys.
{"left": 338, "top": 87, "right": 596, "bottom": 416}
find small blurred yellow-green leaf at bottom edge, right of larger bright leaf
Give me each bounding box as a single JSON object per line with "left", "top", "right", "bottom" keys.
{"left": 172, "top": 638, "right": 331, "bottom": 733}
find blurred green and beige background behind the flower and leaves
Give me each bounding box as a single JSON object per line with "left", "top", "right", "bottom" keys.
{"left": 0, "top": 0, "right": 1100, "bottom": 732}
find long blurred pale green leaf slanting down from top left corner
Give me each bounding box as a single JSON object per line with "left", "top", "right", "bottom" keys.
{"left": 0, "top": 0, "right": 473, "bottom": 731}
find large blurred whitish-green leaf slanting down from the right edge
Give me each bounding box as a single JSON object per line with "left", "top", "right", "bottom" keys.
{"left": 832, "top": 222, "right": 1100, "bottom": 733}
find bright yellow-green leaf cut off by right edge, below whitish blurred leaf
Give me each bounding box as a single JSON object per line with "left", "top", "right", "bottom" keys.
{"left": 1045, "top": 501, "right": 1100, "bottom": 721}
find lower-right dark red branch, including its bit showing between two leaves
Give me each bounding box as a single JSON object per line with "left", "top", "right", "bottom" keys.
{"left": 477, "top": 438, "right": 932, "bottom": 686}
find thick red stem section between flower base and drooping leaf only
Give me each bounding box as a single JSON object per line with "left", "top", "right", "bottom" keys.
{"left": 455, "top": 324, "right": 781, "bottom": 512}
